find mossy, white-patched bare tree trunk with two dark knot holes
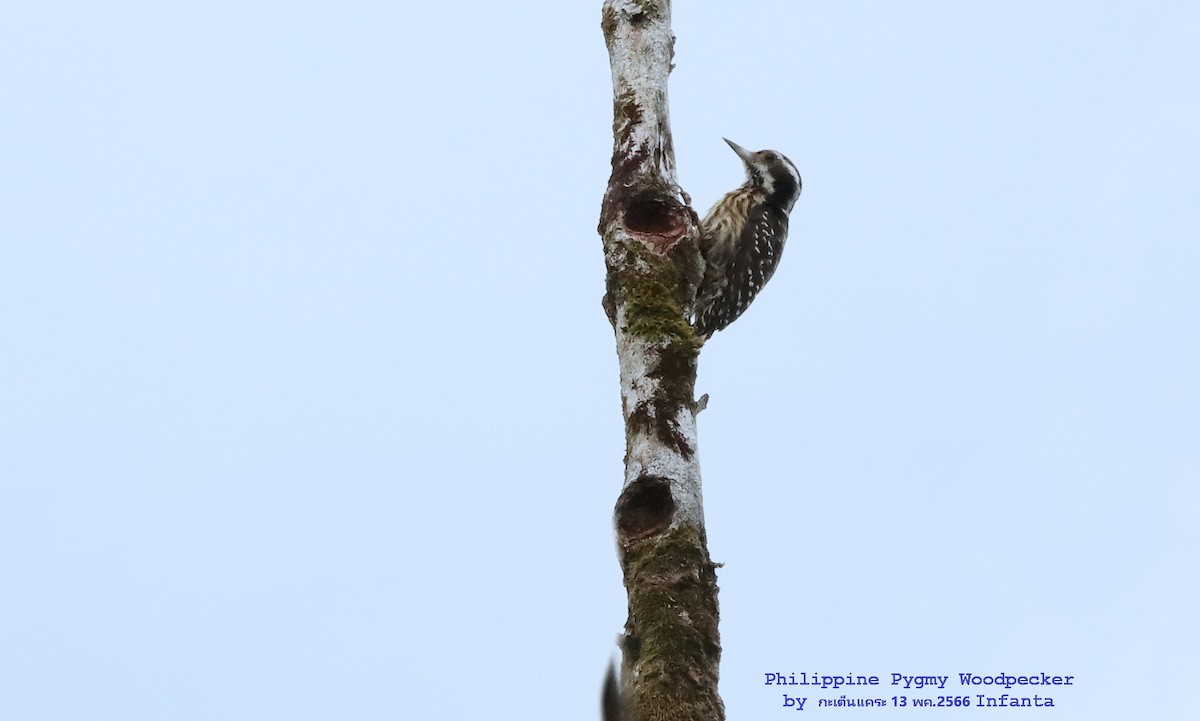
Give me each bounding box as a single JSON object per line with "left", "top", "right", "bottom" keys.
{"left": 599, "top": 0, "right": 725, "bottom": 721}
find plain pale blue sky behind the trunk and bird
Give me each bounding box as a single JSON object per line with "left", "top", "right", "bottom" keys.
{"left": 0, "top": 0, "right": 1200, "bottom": 721}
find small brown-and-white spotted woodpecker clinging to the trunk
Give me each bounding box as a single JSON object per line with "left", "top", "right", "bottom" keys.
{"left": 692, "top": 139, "right": 800, "bottom": 341}
